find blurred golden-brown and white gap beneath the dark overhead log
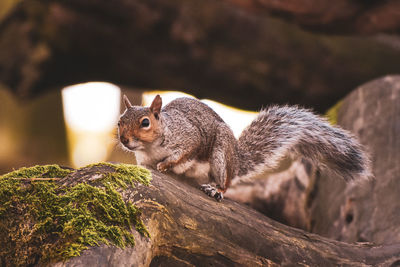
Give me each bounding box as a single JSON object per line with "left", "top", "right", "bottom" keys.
{"left": 0, "top": 82, "right": 257, "bottom": 172}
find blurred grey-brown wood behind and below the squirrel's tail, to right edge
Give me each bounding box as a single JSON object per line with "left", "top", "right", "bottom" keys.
{"left": 228, "top": 76, "right": 400, "bottom": 247}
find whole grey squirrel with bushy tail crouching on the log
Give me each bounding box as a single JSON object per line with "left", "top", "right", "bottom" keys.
{"left": 118, "top": 95, "right": 371, "bottom": 200}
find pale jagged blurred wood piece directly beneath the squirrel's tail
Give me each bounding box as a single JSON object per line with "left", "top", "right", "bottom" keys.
{"left": 225, "top": 159, "right": 316, "bottom": 231}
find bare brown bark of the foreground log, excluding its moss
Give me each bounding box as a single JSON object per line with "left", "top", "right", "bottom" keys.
{"left": 55, "top": 167, "right": 400, "bottom": 266}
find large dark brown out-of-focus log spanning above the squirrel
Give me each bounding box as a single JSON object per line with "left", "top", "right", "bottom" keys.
{"left": 0, "top": 0, "right": 400, "bottom": 112}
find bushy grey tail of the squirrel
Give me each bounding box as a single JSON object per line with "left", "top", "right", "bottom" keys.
{"left": 238, "top": 106, "right": 371, "bottom": 181}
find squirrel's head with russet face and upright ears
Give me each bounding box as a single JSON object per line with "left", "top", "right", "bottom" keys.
{"left": 118, "top": 95, "right": 162, "bottom": 150}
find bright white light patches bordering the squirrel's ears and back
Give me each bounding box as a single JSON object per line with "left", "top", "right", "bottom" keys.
{"left": 143, "top": 91, "right": 258, "bottom": 138}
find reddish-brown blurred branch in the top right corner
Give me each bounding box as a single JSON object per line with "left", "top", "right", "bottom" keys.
{"left": 225, "top": 0, "right": 400, "bottom": 34}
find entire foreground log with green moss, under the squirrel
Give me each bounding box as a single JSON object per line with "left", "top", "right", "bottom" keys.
{"left": 0, "top": 164, "right": 400, "bottom": 267}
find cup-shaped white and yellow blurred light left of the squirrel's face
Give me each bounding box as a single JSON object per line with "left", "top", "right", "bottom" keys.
{"left": 62, "top": 82, "right": 121, "bottom": 167}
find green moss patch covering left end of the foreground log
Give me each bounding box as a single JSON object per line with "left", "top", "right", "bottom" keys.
{"left": 0, "top": 163, "right": 150, "bottom": 266}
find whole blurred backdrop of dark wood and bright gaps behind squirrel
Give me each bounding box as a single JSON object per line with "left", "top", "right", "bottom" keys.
{"left": 0, "top": 0, "right": 400, "bottom": 174}
